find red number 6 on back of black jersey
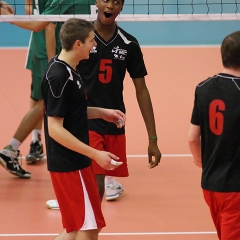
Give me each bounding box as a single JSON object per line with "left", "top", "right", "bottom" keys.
{"left": 209, "top": 99, "right": 225, "bottom": 135}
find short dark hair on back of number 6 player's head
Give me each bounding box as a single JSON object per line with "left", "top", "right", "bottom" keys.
{"left": 221, "top": 31, "right": 240, "bottom": 69}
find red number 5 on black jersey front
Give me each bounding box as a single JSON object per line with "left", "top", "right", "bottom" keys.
{"left": 98, "top": 59, "right": 112, "bottom": 83}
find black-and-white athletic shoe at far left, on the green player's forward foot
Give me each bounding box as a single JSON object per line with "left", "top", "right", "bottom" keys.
{"left": 0, "top": 145, "right": 31, "bottom": 178}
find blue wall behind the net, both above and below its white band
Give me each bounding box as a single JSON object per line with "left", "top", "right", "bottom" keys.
{"left": 0, "top": 0, "right": 240, "bottom": 47}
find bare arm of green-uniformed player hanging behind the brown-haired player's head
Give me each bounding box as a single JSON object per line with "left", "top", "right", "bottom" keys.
{"left": 45, "top": 23, "right": 57, "bottom": 60}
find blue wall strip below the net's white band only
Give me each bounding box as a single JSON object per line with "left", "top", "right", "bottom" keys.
{"left": 0, "top": 21, "right": 240, "bottom": 47}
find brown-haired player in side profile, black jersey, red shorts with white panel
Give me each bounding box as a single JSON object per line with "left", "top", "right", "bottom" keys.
{"left": 42, "top": 18, "right": 125, "bottom": 240}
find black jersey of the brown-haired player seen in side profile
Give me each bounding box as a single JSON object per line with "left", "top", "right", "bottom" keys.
{"left": 42, "top": 57, "right": 91, "bottom": 172}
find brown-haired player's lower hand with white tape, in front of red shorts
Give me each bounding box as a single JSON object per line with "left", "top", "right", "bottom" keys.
{"left": 94, "top": 151, "right": 122, "bottom": 171}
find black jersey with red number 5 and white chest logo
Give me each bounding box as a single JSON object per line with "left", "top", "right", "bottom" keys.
{"left": 78, "top": 27, "right": 147, "bottom": 134}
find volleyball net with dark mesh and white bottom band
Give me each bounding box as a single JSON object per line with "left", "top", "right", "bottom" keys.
{"left": 0, "top": 0, "right": 240, "bottom": 22}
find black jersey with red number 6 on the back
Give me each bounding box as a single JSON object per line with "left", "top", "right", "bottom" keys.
{"left": 191, "top": 74, "right": 240, "bottom": 192}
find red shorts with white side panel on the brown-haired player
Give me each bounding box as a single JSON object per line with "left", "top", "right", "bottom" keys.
{"left": 50, "top": 166, "right": 106, "bottom": 233}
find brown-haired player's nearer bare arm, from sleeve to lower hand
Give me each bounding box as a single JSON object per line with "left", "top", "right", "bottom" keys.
{"left": 48, "top": 117, "right": 119, "bottom": 170}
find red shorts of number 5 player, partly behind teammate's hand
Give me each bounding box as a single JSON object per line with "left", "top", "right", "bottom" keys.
{"left": 89, "top": 131, "right": 129, "bottom": 177}
